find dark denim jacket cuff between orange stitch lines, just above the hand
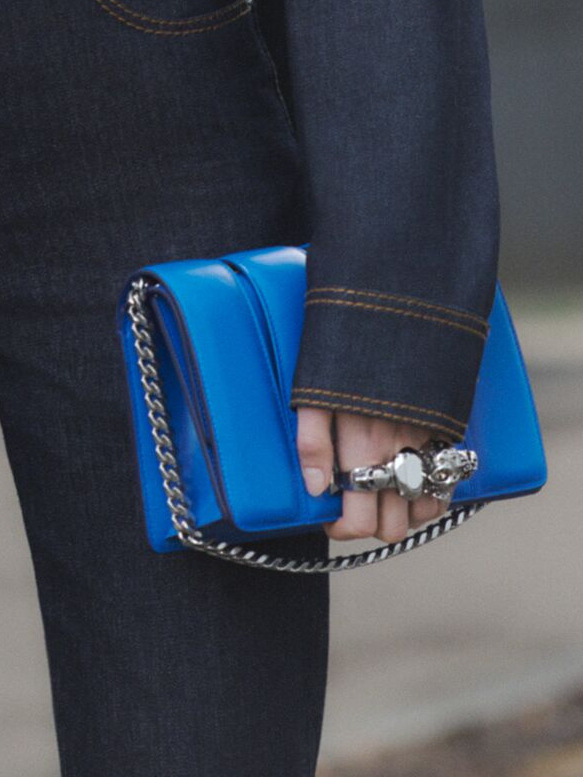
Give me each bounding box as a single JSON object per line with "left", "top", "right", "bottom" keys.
{"left": 290, "top": 286, "right": 490, "bottom": 442}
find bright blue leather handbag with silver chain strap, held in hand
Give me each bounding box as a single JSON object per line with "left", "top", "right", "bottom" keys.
{"left": 117, "top": 244, "right": 547, "bottom": 573}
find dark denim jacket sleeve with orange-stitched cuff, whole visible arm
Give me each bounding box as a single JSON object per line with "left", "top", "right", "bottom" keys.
{"left": 285, "top": 0, "right": 500, "bottom": 441}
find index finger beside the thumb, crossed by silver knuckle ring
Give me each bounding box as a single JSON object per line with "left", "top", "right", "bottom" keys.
{"left": 324, "top": 413, "right": 384, "bottom": 540}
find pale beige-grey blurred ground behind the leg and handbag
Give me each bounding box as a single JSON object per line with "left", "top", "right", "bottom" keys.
{"left": 0, "top": 302, "right": 583, "bottom": 777}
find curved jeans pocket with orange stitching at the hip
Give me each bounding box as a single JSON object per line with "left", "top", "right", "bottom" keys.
{"left": 94, "top": 0, "right": 252, "bottom": 37}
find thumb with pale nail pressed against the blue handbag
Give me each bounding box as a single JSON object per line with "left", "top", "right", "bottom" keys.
{"left": 297, "top": 407, "right": 334, "bottom": 496}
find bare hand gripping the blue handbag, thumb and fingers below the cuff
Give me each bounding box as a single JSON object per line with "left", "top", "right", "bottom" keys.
{"left": 297, "top": 407, "right": 452, "bottom": 543}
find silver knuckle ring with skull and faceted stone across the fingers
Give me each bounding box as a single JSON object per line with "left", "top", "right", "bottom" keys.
{"left": 328, "top": 439, "right": 478, "bottom": 501}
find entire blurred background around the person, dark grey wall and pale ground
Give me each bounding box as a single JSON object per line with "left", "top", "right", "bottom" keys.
{"left": 0, "top": 0, "right": 583, "bottom": 777}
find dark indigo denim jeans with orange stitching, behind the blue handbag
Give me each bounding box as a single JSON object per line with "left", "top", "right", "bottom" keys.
{"left": 0, "top": 0, "right": 328, "bottom": 777}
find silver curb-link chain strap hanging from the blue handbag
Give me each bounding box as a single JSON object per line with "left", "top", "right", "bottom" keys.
{"left": 127, "top": 277, "right": 487, "bottom": 574}
